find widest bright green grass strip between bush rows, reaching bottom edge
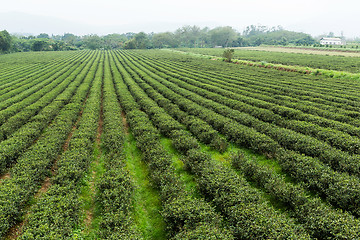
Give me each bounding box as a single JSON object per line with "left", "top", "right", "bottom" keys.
{"left": 125, "top": 133, "right": 166, "bottom": 240}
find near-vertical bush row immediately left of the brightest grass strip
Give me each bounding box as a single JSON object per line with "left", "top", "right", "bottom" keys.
{"left": 96, "top": 53, "right": 142, "bottom": 239}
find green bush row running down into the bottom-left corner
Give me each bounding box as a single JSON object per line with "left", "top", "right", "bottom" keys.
{"left": 0, "top": 50, "right": 97, "bottom": 236}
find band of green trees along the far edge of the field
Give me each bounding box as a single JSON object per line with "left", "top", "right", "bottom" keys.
{"left": 0, "top": 25, "right": 316, "bottom": 53}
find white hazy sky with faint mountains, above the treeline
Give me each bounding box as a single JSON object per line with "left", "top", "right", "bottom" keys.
{"left": 0, "top": 0, "right": 360, "bottom": 37}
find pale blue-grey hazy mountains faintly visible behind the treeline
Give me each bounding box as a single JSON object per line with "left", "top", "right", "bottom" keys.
{"left": 0, "top": 12, "right": 360, "bottom": 38}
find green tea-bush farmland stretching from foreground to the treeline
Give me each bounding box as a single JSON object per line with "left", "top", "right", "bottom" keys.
{"left": 0, "top": 49, "right": 360, "bottom": 239}
